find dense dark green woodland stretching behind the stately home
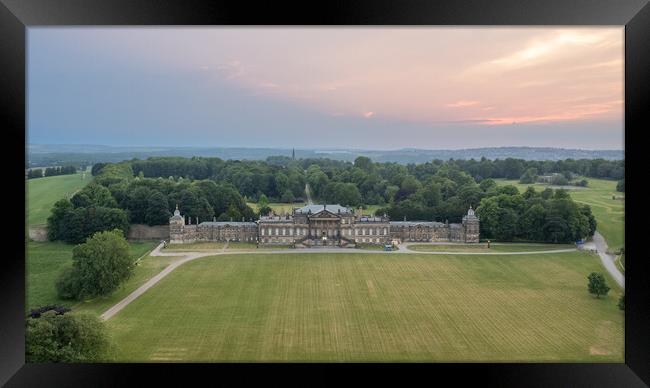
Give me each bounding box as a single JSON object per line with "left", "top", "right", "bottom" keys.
{"left": 48, "top": 156, "right": 608, "bottom": 242}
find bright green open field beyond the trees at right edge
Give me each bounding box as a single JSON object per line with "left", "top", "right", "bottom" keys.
{"left": 495, "top": 178, "right": 625, "bottom": 251}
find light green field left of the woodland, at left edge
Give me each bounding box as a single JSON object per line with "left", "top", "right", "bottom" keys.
{"left": 26, "top": 172, "right": 92, "bottom": 226}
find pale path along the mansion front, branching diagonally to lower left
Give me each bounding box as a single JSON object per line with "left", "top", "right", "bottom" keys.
{"left": 100, "top": 243, "right": 576, "bottom": 320}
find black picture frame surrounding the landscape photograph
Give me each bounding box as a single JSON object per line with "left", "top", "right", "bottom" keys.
{"left": 0, "top": 0, "right": 650, "bottom": 387}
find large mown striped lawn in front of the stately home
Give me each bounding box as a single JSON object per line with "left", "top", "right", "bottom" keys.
{"left": 107, "top": 252, "right": 624, "bottom": 362}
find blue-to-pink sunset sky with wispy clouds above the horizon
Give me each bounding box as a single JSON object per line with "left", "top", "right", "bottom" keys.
{"left": 27, "top": 27, "right": 624, "bottom": 149}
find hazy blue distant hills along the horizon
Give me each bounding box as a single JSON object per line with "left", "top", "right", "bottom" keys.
{"left": 27, "top": 144, "right": 625, "bottom": 167}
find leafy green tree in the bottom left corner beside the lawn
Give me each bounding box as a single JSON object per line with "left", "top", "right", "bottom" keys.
{"left": 25, "top": 311, "right": 109, "bottom": 363}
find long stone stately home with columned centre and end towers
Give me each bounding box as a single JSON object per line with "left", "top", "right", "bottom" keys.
{"left": 169, "top": 205, "right": 479, "bottom": 247}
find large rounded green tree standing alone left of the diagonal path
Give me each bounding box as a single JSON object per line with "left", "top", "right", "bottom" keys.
{"left": 56, "top": 230, "right": 134, "bottom": 300}
